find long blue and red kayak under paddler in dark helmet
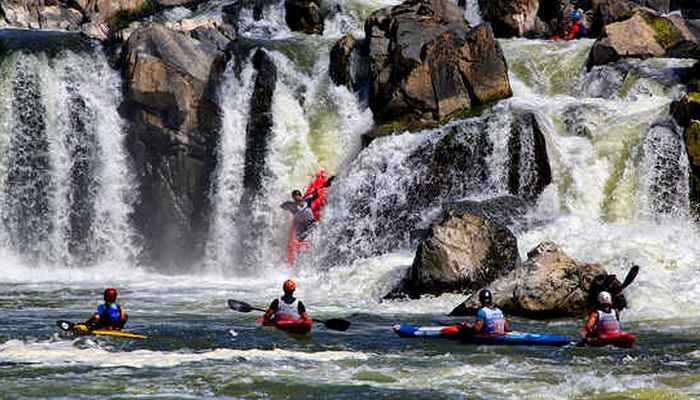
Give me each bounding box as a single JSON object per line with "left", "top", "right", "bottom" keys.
{"left": 393, "top": 324, "right": 571, "bottom": 346}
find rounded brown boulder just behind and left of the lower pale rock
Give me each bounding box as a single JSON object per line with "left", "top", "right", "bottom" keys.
{"left": 388, "top": 211, "right": 520, "bottom": 298}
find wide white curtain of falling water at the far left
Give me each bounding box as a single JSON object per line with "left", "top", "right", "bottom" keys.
{"left": 0, "top": 37, "right": 138, "bottom": 265}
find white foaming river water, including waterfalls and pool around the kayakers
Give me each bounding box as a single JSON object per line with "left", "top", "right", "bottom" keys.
{"left": 0, "top": 0, "right": 700, "bottom": 399}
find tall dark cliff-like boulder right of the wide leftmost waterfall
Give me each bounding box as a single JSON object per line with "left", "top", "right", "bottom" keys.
{"left": 121, "top": 24, "right": 225, "bottom": 266}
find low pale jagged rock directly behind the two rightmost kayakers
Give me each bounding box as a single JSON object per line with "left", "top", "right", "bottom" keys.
{"left": 450, "top": 242, "right": 607, "bottom": 318}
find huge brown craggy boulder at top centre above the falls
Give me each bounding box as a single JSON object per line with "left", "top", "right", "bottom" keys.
{"left": 365, "top": 0, "right": 511, "bottom": 123}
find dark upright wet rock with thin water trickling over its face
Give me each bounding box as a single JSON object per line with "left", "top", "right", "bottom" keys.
{"left": 508, "top": 112, "right": 552, "bottom": 202}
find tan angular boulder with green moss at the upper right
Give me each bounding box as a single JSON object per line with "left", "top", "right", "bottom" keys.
{"left": 588, "top": 10, "right": 700, "bottom": 67}
